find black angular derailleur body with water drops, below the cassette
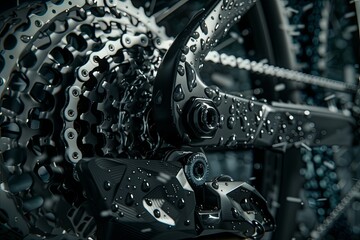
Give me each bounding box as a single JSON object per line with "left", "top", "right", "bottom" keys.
{"left": 77, "top": 154, "right": 275, "bottom": 239}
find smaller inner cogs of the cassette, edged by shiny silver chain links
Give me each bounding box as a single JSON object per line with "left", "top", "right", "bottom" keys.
{"left": 64, "top": 18, "right": 167, "bottom": 163}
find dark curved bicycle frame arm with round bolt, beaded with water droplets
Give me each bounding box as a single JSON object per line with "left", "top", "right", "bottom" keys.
{"left": 153, "top": 0, "right": 354, "bottom": 151}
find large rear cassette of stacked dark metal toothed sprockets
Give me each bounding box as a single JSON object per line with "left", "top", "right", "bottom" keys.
{"left": 0, "top": 0, "right": 169, "bottom": 237}
